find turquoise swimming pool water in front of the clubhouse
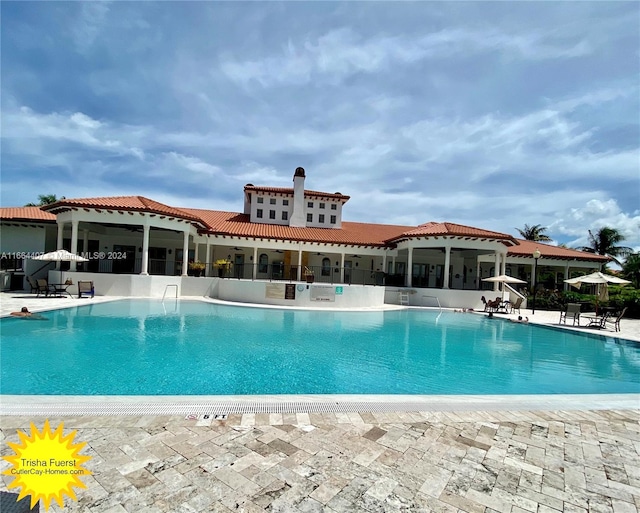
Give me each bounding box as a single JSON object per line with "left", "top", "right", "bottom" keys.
{"left": 0, "top": 300, "right": 640, "bottom": 395}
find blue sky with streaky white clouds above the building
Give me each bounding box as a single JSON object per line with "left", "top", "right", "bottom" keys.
{"left": 0, "top": 1, "right": 640, "bottom": 250}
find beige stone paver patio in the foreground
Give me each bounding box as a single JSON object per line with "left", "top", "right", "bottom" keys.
{"left": 0, "top": 410, "right": 640, "bottom": 513}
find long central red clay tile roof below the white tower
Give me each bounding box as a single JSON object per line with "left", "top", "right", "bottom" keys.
{"left": 182, "top": 208, "right": 411, "bottom": 246}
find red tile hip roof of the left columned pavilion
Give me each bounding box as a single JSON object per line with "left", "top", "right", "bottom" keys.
{"left": 42, "top": 196, "right": 210, "bottom": 227}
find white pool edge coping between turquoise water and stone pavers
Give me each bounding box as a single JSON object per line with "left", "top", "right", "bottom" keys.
{"left": 0, "top": 393, "right": 640, "bottom": 416}
